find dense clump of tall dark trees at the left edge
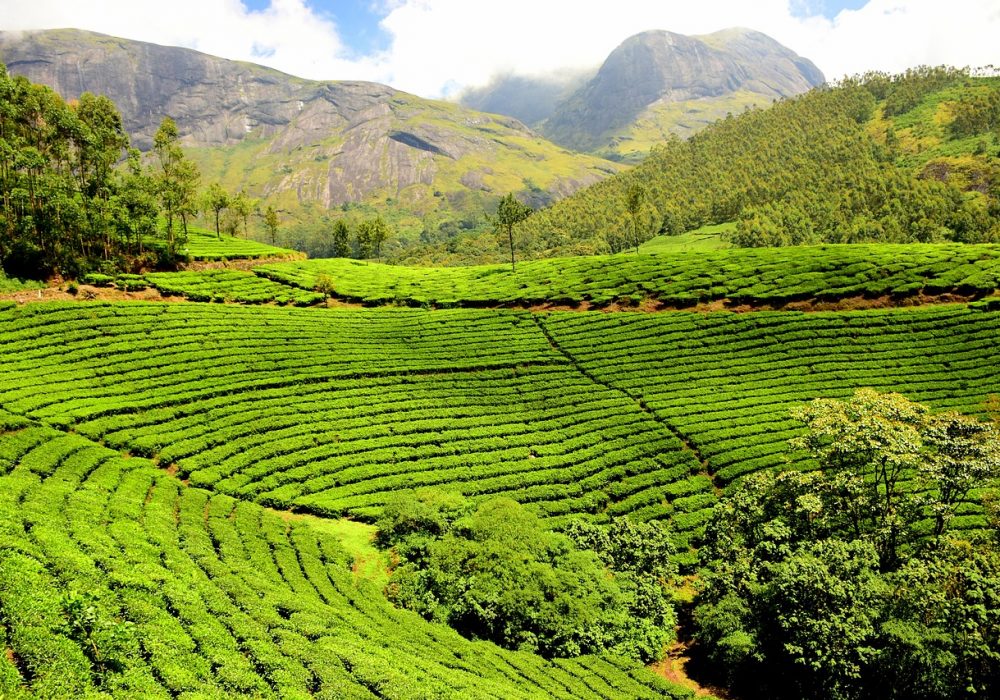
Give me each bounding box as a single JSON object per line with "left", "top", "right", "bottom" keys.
{"left": 0, "top": 65, "right": 142, "bottom": 278}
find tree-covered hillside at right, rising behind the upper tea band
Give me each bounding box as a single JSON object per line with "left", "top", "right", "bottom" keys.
{"left": 520, "top": 68, "right": 1000, "bottom": 257}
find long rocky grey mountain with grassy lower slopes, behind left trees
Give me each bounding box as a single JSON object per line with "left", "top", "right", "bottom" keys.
{"left": 0, "top": 29, "right": 616, "bottom": 230}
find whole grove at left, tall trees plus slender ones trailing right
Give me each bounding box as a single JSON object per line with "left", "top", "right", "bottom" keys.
{"left": 0, "top": 65, "right": 300, "bottom": 279}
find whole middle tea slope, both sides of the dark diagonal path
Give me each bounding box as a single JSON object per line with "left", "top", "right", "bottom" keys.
{"left": 0, "top": 303, "right": 1000, "bottom": 542}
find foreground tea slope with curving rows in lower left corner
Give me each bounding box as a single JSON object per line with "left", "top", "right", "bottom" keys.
{"left": 0, "top": 411, "right": 672, "bottom": 699}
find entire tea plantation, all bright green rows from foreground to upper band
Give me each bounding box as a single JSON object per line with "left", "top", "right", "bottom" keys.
{"left": 0, "top": 252, "right": 1000, "bottom": 698}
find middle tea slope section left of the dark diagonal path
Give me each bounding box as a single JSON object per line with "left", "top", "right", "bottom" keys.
{"left": 0, "top": 303, "right": 711, "bottom": 531}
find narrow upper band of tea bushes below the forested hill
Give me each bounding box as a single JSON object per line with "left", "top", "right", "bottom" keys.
{"left": 255, "top": 244, "right": 1000, "bottom": 306}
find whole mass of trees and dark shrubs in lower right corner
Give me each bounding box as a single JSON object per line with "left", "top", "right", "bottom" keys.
{"left": 695, "top": 390, "right": 1000, "bottom": 698}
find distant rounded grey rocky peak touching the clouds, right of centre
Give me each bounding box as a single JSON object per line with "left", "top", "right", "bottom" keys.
{"left": 463, "top": 29, "right": 824, "bottom": 160}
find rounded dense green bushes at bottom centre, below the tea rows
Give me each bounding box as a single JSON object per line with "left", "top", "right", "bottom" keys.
{"left": 378, "top": 491, "right": 673, "bottom": 661}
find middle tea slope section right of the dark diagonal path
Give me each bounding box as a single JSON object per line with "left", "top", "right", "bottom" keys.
{"left": 544, "top": 306, "right": 1000, "bottom": 525}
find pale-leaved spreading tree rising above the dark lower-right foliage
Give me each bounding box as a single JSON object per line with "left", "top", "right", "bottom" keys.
{"left": 792, "top": 389, "right": 1000, "bottom": 570}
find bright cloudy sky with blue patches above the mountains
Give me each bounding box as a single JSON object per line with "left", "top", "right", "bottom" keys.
{"left": 7, "top": 0, "right": 1000, "bottom": 97}
